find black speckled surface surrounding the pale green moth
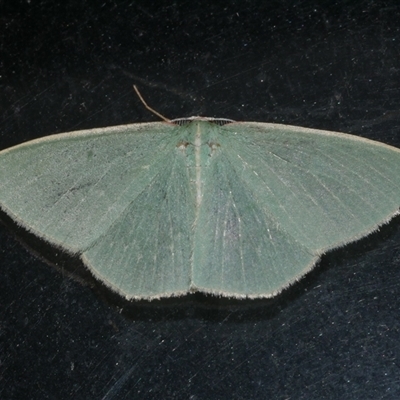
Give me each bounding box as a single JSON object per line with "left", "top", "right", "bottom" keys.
{"left": 0, "top": 0, "right": 400, "bottom": 399}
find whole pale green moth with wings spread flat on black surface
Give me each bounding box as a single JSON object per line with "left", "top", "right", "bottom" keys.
{"left": 0, "top": 117, "right": 400, "bottom": 299}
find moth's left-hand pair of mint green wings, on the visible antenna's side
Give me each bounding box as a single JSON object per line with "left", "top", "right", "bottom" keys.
{"left": 0, "top": 123, "right": 194, "bottom": 298}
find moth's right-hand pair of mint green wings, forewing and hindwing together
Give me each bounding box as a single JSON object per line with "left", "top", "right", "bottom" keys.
{"left": 193, "top": 122, "right": 400, "bottom": 297}
